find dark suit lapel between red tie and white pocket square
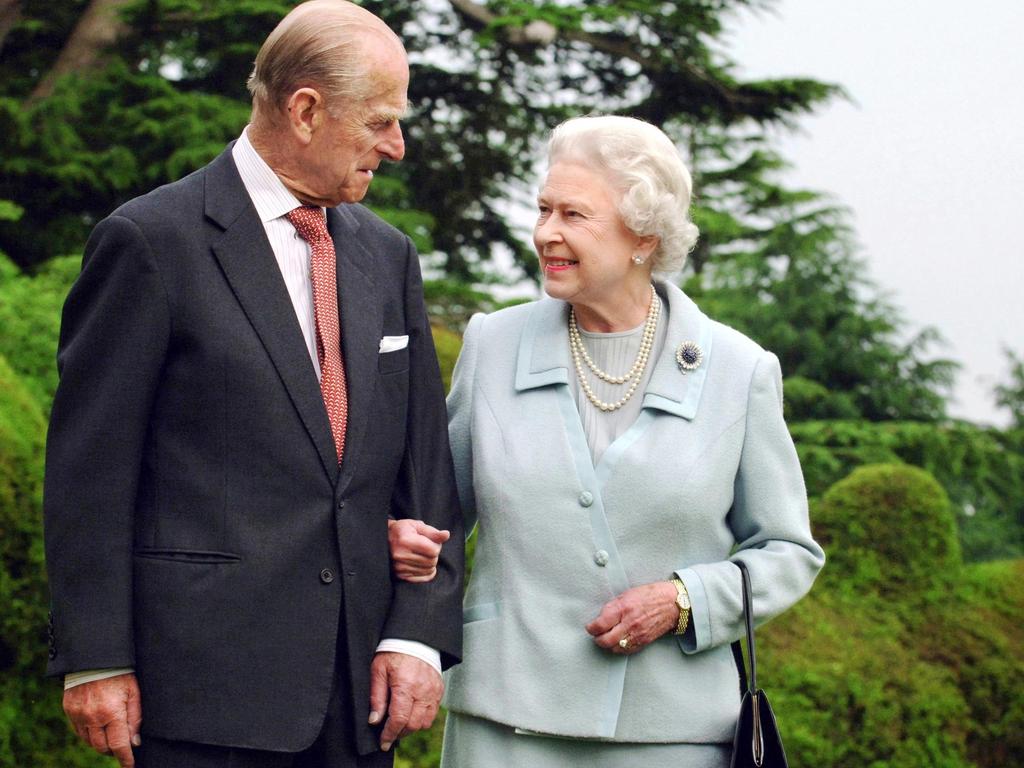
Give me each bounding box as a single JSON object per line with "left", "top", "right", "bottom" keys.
{"left": 327, "top": 207, "right": 384, "bottom": 488}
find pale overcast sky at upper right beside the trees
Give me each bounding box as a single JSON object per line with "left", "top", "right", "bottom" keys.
{"left": 729, "top": 0, "right": 1024, "bottom": 424}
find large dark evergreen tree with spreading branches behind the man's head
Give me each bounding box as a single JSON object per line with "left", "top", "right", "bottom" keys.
{"left": 0, "top": 0, "right": 836, "bottom": 279}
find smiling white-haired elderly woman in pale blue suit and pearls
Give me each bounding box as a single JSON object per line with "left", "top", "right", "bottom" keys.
{"left": 393, "top": 117, "right": 824, "bottom": 768}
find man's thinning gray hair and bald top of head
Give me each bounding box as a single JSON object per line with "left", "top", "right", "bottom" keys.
{"left": 247, "top": 0, "right": 401, "bottom": 119}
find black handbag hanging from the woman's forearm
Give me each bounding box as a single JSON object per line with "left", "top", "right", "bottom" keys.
{"left": 729, "top": 560, "right": 790, "bottom": 768}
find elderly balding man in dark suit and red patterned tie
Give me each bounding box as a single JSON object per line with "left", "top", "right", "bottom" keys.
{"left": 45, "top": 0, "right": 463, "bottom": 768}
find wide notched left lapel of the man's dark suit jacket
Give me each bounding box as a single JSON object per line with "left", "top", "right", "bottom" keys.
{"left": 206, "top": 148, "right": 338, "bottom": 481}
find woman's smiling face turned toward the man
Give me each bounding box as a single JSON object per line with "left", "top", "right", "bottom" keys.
{"left": 534, "top": 162, "right": 650, "bottom": 310}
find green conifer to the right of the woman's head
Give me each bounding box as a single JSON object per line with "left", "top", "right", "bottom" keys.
{"left": 684, "top": 126, "right": 957, "bottom": 421}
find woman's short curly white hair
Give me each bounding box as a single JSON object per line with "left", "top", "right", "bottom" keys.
{"left": 548, "top": 115, "right": 699, "bottom": 276}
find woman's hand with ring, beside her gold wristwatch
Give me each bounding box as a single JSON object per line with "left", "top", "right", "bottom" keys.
{"left": 587, "top": 582, "right": 679, "bottom": 654}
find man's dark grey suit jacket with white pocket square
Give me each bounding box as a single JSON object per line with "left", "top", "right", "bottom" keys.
{"left": 44, "top": 150, "right": 463, "bottom": 753}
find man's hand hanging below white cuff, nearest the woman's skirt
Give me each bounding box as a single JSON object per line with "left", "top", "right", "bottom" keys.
{"left": 370, "top": 652, "right": 444, "bottom": 752}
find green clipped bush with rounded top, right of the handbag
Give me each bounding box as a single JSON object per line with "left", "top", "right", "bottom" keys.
{"left": 759, "top": 465, "right": 1024, "bottom": 768}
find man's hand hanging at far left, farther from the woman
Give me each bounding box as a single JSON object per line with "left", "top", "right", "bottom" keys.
{"left": 63, "top": 675, "right": 142, "bottom": 768}
